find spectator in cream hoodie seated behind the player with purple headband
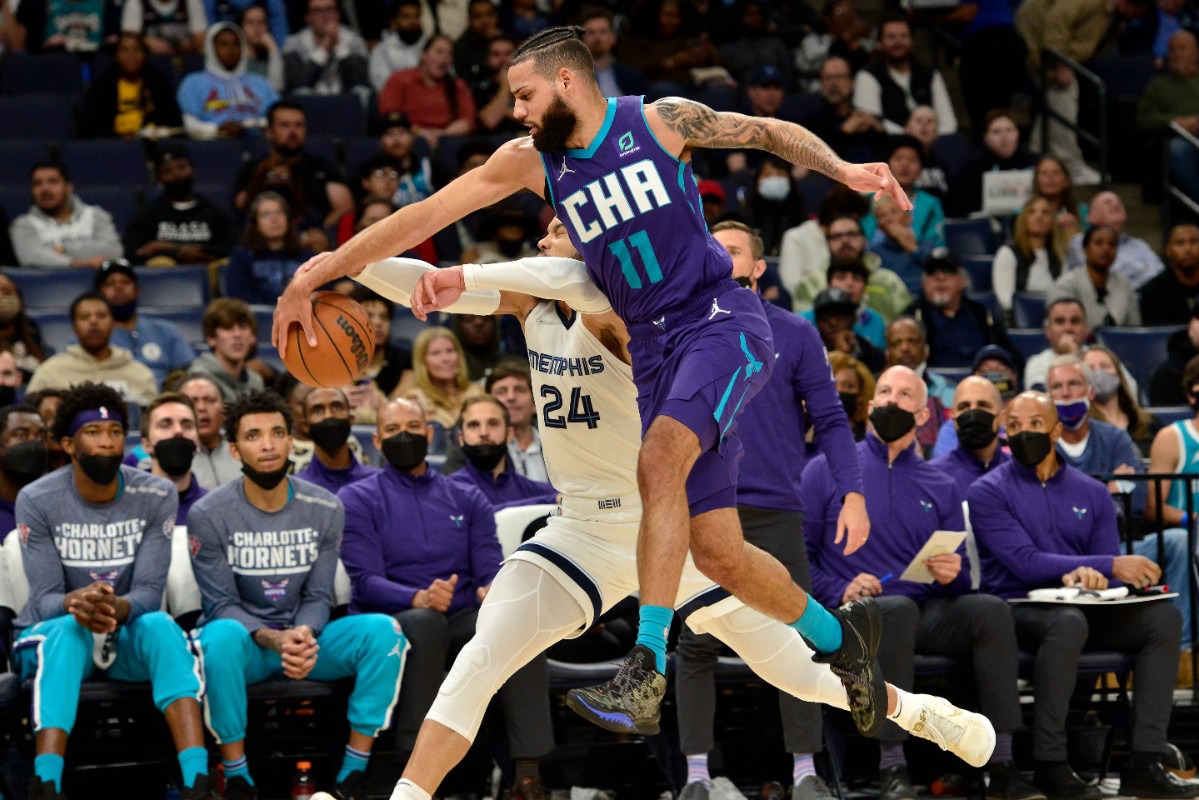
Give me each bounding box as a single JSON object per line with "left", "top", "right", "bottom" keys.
{"left": 29, "top": 291, "right": 158, "bottom": 405}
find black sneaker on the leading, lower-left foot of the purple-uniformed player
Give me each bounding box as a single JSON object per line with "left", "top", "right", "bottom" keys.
{"left": 566, "top": 644, "right": 667, "bottom": 735}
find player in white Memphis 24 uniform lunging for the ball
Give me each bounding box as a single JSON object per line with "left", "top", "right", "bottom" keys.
{"left": 317, "top": 218, "right": 995, "bottom": 800}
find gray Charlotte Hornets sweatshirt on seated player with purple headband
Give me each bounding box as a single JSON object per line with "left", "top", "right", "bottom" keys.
{"left": 17, "top": 464, "right": 179, "bottom": 627}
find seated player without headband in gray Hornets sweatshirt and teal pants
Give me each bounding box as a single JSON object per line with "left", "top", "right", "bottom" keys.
{"left": 188, "top": 392, "right": 408, "bottom": 799}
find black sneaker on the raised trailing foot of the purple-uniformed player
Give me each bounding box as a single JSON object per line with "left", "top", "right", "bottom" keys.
{"left": 808, "top": 597, "right": 887, "bottom": 738}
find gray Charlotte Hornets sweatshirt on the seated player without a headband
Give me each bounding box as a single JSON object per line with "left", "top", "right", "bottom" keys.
{"left": 187, "top": 477, "right": 345, "bottom": 633}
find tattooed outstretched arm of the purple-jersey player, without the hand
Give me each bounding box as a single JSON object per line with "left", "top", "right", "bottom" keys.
{"left": 653, "top": 97, "right": 842, "bottom": 178}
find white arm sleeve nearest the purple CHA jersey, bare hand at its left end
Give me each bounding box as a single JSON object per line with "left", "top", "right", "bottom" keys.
{"left": 462, "top": 255, "right": 611, "bottom": 314}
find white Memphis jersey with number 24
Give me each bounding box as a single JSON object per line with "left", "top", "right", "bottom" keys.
{"left": 524, "top": 301, "right": 641, "bottom": 510}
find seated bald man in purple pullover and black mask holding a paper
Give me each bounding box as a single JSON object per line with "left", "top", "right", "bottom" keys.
{"left": 800, "top": 366, "right": 1043, "bottom": 800}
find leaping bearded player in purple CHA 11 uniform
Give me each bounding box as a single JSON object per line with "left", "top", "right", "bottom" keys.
{"left": 275, "top": 28, "right": 911, "bottom": 733}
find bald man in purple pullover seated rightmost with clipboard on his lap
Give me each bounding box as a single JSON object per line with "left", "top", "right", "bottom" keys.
{"left": 968, "top": 392, "right": 1199, "bottom": 800}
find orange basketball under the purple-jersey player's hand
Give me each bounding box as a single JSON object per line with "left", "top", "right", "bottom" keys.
{"left": 283, "top": 291, "right": 375, "bottom": 386}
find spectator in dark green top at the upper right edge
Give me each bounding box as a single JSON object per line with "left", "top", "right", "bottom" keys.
{"left": 1137, "top": 30, "right": 1199, "bottom": 205}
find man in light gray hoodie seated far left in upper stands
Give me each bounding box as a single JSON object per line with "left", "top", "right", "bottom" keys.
{"left": 8, "top": 162, "right": 122, "bottom": 269}
